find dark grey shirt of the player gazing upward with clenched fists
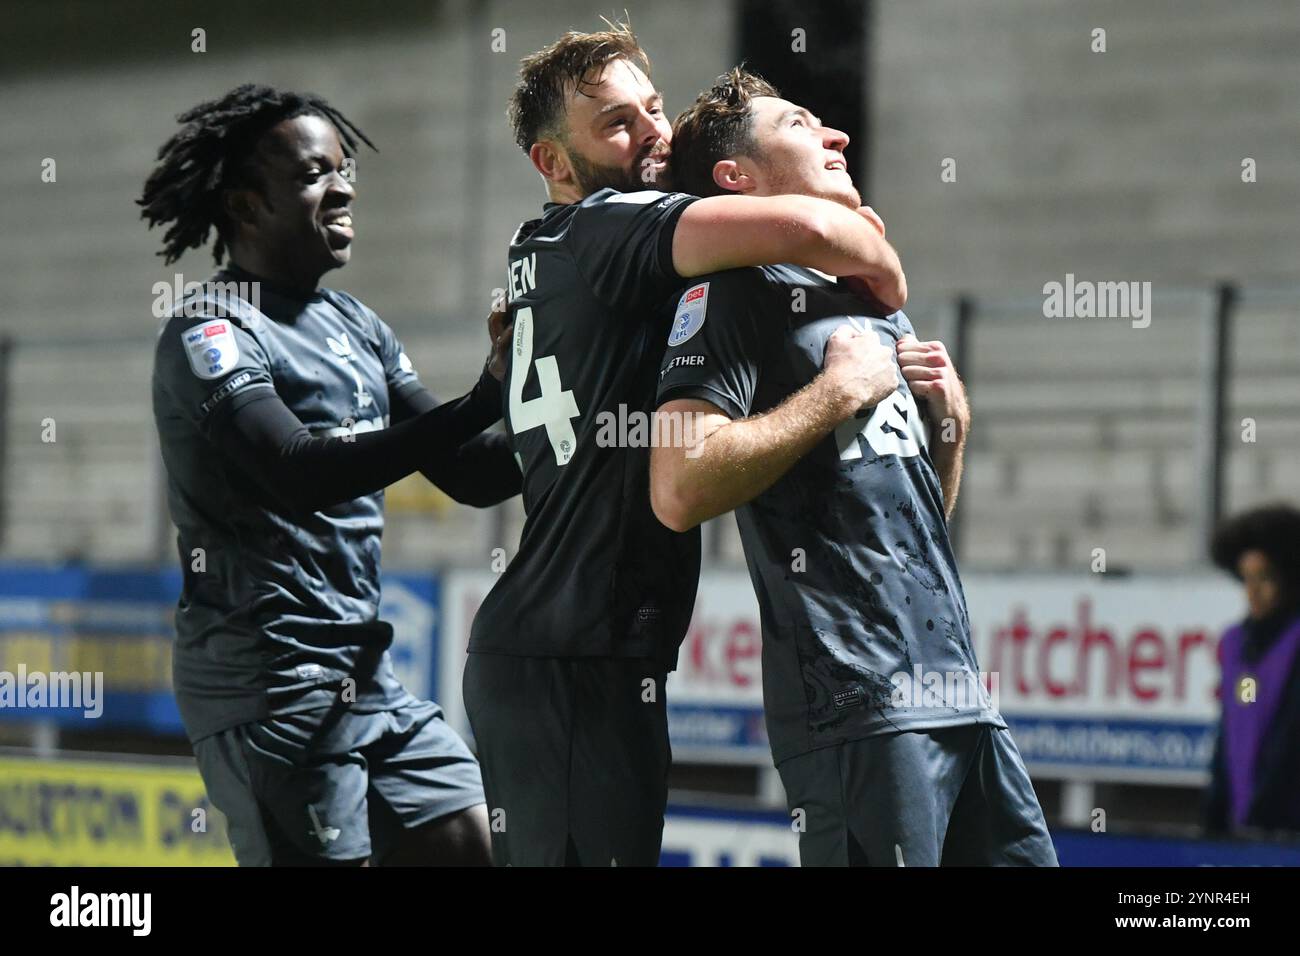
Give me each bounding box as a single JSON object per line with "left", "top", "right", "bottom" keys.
{"left": 659, "top": 265, "right": 1005, "bottom": 762}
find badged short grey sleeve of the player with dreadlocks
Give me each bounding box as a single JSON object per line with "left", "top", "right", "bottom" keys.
{"left": 153, "top": 315, "right": 276, "bottom": 434}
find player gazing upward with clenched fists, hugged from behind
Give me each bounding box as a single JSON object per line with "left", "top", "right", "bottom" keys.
{"left": 651, "top": 69, "right": 1057, "bottom": 866}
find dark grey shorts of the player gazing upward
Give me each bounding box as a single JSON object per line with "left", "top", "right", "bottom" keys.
{"left": 777, "top": 724, "right": 1058, "bottom": 866}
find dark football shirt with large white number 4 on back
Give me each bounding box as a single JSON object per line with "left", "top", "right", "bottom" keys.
{"left": 469, "top": 189, "right": 699, "bottom": 667}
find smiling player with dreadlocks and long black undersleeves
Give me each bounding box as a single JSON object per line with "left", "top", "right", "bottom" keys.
{"left": 139, "top": 85, "right": 520, "bottom": 865}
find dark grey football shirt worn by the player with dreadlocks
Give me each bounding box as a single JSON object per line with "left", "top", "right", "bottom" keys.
{"left": 152, "top": 265, "right": 423, "bottom": 740}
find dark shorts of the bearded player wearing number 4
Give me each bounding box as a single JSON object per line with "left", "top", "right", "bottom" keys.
{"left": 464, "top": 654, "right": 672, "bottom": 866}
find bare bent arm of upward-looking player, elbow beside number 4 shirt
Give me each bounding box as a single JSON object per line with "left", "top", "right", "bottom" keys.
{"left": 650, "top": 326, "right": 898, "bottom": 532}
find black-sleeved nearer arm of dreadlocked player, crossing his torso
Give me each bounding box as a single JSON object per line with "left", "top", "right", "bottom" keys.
{"left": 209, "top": 369, "right": 502, "bottom": 520}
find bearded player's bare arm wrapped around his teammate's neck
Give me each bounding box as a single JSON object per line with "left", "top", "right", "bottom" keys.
{"left": 672, "top": 195, "right": 907, "bottom": 308}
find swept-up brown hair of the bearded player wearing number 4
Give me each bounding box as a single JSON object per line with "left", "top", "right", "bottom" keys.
{"left": 507, "top": 20, "right": 650, "bottom": 152}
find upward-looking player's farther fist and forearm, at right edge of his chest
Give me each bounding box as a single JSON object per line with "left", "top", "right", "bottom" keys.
{"left": 897, "top": 334, "right": 971, "bottom": 518}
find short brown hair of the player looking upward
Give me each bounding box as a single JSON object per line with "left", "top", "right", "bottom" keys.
{"left": 671, "top": 66, "right": 780, "bottom": 196}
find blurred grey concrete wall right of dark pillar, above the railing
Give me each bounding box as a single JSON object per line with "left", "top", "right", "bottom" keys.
{"left": 870, "top": 0, "right": 1300, "bottom": 295}
